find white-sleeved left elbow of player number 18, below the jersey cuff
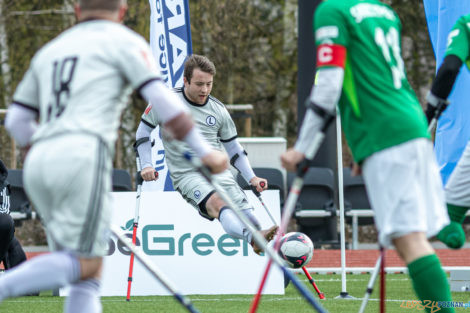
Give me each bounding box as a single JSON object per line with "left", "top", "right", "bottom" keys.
{"left": 5, "top": 102, "right": 38, "bottom": 147}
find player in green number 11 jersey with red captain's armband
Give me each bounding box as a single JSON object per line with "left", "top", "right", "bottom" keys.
{"left": 281, "top": 0, "right": 454, "bottom": 312}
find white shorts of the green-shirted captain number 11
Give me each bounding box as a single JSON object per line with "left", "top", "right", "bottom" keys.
{"left": 362, "top": 138, "right": 449, "bottom": 247}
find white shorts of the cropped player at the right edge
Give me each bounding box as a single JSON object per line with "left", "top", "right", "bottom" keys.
{"left": 445, "top": 141, "right": 470, "bottom": 207}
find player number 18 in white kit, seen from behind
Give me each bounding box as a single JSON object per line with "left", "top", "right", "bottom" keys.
{"left": 0, "top": 0, "right": 228, "bottom": 313}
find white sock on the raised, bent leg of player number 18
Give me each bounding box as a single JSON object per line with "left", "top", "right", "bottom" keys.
{"left": 0, "top": 252, "right": 80, "bottom": 300}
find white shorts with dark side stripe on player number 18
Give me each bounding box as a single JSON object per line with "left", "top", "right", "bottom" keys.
{"left": 24, "top": 134, "right": 111, "bottom": 257}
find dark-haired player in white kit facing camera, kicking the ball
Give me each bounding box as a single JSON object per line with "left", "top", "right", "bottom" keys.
{"left": 136, "top": 54, "right": 277, "bottom": 254}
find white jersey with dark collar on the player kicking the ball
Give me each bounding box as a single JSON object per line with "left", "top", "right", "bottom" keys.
{"left": 142, "top": 88, "right": 237, "bottom": 183}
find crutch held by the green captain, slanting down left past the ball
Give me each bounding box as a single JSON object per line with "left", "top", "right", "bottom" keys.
{"left": 249, "top": 112, "right": 335, "bottom": 313}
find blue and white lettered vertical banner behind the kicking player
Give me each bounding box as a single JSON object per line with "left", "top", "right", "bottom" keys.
{"left": 142, "top": 0, "right": 192, "bottom": 191}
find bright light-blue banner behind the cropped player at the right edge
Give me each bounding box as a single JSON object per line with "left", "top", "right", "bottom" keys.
{"left": 423, "top": 0, "right": 470, "bottom": 184}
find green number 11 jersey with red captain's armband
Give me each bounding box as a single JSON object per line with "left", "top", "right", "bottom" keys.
{"left": 314, "top": 0, "right": 429, "bottom": 162}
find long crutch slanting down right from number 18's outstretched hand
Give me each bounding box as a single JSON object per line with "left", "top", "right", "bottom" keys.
{"left": 184, "top": 153, "right": 327, "bottom": 313}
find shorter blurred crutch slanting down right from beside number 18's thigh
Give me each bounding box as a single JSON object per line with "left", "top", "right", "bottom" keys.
{"left": 111, "top": 225, "right": 199, "bottom": 313}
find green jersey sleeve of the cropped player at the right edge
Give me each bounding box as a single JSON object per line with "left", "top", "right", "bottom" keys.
{"left": 445, "top": 14, "right": 470, "bottom": 69}
